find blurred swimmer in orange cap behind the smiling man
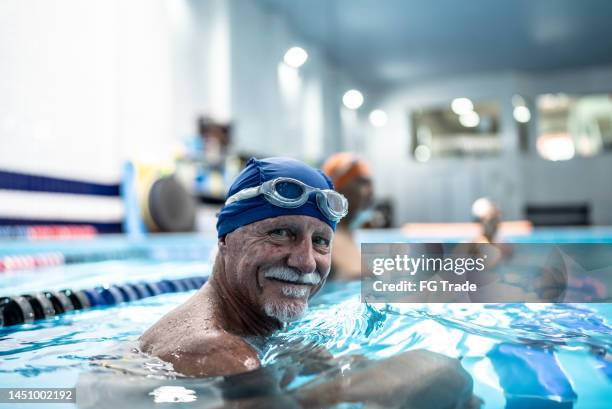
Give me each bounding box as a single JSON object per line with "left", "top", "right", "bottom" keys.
{"left": 322, "top": 152, "right": 374, "bottom": 280}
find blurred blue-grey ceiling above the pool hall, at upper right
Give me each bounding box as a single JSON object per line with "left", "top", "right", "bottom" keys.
{"left": 259, "top": 0, "right": 612, "bottom": 85}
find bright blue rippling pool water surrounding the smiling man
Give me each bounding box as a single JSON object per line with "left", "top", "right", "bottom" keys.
{"left": 0, "top": 230, "right": 612, "bottom": 409}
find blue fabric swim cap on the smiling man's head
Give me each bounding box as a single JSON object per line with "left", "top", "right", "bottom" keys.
{"left": 217, "top": 157, "right": 336, "bottom": 237}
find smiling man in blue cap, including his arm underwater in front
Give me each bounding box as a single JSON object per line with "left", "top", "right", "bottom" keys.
{"left": 140, "top": 158, "right": 477, "bottom": 408}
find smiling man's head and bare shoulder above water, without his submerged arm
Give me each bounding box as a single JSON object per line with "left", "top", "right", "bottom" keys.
{"left": 140, "top": 158, "right": 347, "bottom": 376}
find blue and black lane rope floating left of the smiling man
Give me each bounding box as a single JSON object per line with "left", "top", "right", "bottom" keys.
{"left": 0, "top": 276, "right": 207, "bottom": 327}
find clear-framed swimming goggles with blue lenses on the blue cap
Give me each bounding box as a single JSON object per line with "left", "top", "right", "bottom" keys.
{"left": 225, "top": 177, "right": 348, "bottom": 222}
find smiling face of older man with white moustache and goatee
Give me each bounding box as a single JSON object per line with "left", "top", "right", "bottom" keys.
{"left": 219, "top": 216, "right": 333, "bottom": 322}
